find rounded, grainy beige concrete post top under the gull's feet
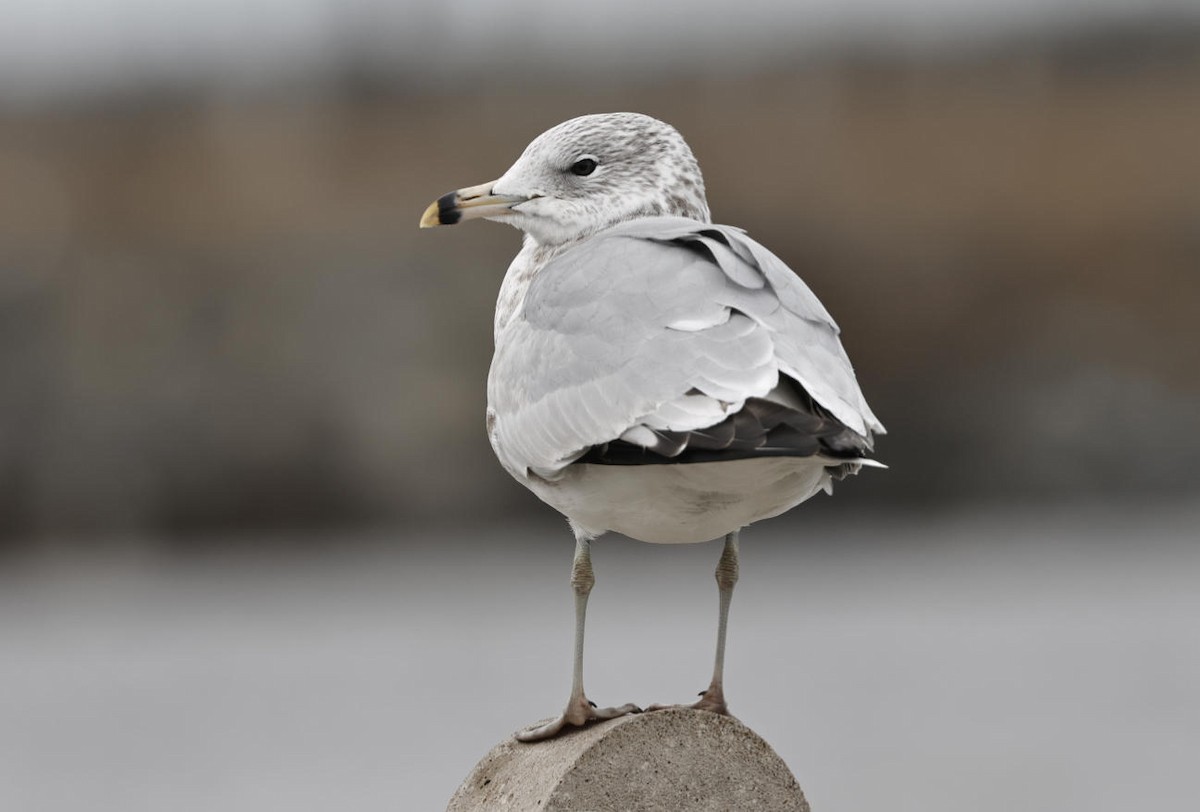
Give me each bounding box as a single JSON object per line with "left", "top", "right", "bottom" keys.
{"left": 446, "top": 708, "right": 809, "bottom": 812}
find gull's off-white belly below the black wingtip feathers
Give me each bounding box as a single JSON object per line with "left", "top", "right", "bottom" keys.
{"left": 523, "top": 457, "right": 830, "bottom": 543}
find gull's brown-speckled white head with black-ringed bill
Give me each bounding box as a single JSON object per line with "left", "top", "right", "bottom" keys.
{"left": 421, "top": 113, "right": 709, "bottom": 246}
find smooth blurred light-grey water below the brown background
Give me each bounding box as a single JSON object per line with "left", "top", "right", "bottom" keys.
{"left": 0, "top": 504, "right": 1200, "bottom": 812}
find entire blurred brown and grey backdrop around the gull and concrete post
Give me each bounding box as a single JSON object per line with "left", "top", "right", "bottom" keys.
{"left": 0, "top": 0, "right": 1200, "bottom": 810}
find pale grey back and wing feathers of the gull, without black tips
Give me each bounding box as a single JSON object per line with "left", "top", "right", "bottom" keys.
{"left": 488, "top": 217, "right": 883, "bottom": 479}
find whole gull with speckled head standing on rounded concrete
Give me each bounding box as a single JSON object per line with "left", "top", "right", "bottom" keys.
{"left": 420, "top": 113, "right": 884, "bottom": 741}
